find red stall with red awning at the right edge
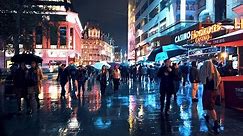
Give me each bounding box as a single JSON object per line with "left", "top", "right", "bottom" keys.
{"left": 208, "top": 26, "right": 243, "bottom": 111}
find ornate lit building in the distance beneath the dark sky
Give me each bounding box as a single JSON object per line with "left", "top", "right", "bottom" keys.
{"left": 81, "top": 23, "right": 114, "bottom": 65}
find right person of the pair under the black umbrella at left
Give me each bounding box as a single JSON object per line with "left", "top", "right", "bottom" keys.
{"left": 27, "top": 61, "right": 43, "bottom": 112}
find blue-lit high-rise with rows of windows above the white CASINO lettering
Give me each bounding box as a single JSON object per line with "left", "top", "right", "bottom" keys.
{"left": 132, "top": 0, "right": 198, "bottom": 61}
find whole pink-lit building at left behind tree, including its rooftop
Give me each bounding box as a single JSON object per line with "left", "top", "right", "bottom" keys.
{"left": 0, "top": 0, "right": 83, "bottom": 69}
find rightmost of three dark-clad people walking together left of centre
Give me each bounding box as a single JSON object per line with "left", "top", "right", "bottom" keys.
{"left": 77, "top": 65, "right": 88, "bottom": 97}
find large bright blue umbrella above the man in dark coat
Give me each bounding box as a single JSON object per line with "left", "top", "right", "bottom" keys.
{"left": 148, "top": 44, "right": 186, "bottom": 61}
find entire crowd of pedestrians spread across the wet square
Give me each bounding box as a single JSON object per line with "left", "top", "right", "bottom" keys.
{"left": 9, "top": 55, "right": 237, "bottom": 133}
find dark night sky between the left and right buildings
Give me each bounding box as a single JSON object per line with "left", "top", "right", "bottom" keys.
{"left": 72, "top": 0, "right": 128, "bottom": 50}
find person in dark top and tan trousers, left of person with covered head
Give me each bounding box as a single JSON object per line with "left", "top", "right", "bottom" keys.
{"left": 189, "top": 61, "right": 199, "bottom": 102}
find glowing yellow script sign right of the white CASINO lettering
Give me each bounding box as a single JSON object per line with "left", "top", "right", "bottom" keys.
{"left": 191, "top": 24, "right": 222, "bottom": 43}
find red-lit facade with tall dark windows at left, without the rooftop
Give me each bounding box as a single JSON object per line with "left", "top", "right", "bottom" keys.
{"left": 34, "top": 12, "right": 82, "bottom": 65}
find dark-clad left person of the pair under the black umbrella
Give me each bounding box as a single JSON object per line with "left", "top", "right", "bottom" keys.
{"left": 13, "top": 62, "right": 30, "bottom": 112}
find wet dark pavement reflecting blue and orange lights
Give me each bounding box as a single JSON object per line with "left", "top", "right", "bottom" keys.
{"left": 0, "top": 79, "right": 243, "bottom": 136}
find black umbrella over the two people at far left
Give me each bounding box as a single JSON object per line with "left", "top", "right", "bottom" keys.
{"left": 11, "top": 54, "right": 43, "bottom": 64}
